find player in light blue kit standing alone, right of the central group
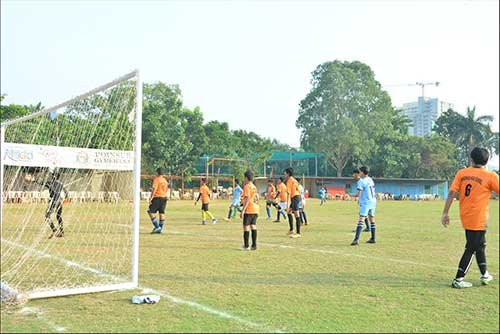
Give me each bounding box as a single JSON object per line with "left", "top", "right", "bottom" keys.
{"left": 351, "top": 166, "right": 377, "bottom": 246}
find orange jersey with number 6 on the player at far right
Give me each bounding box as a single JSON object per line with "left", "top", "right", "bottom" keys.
{"left": 450, "top": 167, "right": 498, "bottom": 231}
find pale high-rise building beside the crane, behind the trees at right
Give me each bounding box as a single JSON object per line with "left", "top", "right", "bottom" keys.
{"left": 402, "top": 97, "right": 454, "bottom": 137}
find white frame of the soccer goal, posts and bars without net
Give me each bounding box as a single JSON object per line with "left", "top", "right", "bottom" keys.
{"left": 0, "top": 69, "right": 142, "bottom": 300}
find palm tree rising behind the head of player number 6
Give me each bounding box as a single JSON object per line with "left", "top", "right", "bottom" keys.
{"left": 434, "top": 107, "right": 498, "bottom": 167}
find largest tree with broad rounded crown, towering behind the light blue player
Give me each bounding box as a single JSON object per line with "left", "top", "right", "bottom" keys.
{"left": 296, "top": 60, "right": 404, "bottom": 176}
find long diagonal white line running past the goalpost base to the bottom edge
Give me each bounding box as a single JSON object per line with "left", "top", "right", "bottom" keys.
{"left": 2, "top": 239, "right": 282, "bottom": 333}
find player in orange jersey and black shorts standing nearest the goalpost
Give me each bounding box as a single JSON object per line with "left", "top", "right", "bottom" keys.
{"left": 148, "top": 168, "right": 168, "bottom": 233}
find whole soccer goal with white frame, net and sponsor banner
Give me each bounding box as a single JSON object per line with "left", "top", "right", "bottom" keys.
{"left": 0, "top": 71, "right": 142, "bottom": 301}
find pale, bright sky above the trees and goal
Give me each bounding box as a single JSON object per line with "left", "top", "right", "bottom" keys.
{"left": 1, "top": 0, "right": 499, "bottom": 153}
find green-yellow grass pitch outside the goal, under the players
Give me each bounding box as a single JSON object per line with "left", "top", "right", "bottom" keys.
{"left": 1, "top": 200, "right": 499, "bottom": 332}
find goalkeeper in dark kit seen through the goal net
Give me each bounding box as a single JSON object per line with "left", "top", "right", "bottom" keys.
{"left": 39, "top": 171, "right": 68, "bottom": 239}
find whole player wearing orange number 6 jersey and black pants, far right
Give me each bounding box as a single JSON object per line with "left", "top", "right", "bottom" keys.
{"left": 441, "top": 147, "right": 499, "bottom": 289}
